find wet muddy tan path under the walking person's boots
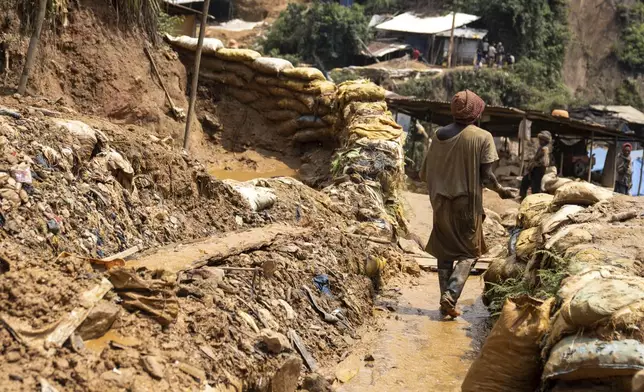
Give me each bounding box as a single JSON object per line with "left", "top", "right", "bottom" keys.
{"left": 336, "top": 193, "right": 488, "bottom": 392}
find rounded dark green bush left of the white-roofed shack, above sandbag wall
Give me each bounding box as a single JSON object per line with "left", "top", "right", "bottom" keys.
{"left": 263, "top": 2, "right": 369, "bottom": 68}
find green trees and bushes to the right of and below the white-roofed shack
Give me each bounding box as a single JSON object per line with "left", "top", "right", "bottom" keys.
{"left": 390, "top": 0, "right": 571, "bottom": 111}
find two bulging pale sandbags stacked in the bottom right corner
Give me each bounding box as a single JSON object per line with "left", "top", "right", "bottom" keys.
{"left": 542, "top": 267, "right": 644, "bottom": 382}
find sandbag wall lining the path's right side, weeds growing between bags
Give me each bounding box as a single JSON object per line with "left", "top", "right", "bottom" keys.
{"left": 484, "top": 174, "right": 644, "bottom": 391}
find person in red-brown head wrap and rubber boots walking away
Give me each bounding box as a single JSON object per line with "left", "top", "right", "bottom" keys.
{"left": 421, "top": 90, "right": 514, "bottom": 318}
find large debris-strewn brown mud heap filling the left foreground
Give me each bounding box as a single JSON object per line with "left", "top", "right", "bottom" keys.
{"left": 0, "top": 98, "right": 416, "bottom": 391}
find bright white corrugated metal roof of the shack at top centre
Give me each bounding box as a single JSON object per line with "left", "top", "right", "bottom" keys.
{"left": 376, "top": 12, "right": 481, "bottom": 34}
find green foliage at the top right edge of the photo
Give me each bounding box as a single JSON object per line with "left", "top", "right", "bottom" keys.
{"left": 616, "top": 2, "right": 644, "bottom": 72}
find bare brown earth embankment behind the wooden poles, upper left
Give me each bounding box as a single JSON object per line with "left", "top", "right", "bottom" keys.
{"left": 0, "top": 0, "right": 219, "bottom": 161}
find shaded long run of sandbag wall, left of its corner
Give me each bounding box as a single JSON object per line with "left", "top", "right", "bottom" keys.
{"left": 166, "top": 36, "right": 337, "bottom": 143}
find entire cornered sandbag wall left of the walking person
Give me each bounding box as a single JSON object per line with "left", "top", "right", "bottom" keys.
{"left": 166, "top": 36, "right": 406, "bottom": 235}
